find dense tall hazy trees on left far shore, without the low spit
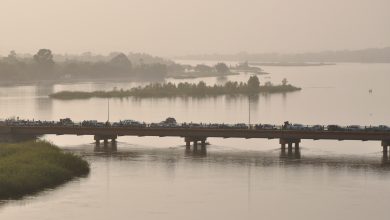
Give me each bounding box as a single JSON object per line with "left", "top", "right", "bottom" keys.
{"left": 0, "top": 49, "right": 168, "bottom": 81}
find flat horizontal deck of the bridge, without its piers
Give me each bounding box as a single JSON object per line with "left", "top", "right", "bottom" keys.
{"left": 0, "top": 126, "right": 390, "bottom": 141}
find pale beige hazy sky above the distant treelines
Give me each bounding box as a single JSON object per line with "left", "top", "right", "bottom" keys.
{"left": 0, "top": 0, "right": 390, "bottom": 56}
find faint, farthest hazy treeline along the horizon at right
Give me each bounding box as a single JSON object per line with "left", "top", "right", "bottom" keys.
{"left": 178, "top": 47, "right": 390, "bottom": 63}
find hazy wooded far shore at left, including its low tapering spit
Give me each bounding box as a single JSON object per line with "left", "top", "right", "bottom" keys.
{"left": 0, "top": 49, "right": 238, "bottom": 82}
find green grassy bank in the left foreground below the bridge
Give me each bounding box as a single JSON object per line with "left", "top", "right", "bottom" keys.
{"left": 0, "top": 141, "right": 89, "bottom": 199}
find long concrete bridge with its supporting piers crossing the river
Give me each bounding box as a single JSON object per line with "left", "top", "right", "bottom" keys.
{"left": 0, "top": 125, "right": 390, "bottom": 158}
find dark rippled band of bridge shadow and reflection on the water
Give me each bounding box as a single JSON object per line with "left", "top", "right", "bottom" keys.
{"left": 71, "top": 143, "right": 390, "bottom": 174}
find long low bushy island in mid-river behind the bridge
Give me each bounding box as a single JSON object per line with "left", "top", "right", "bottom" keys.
{"left": 49, "top": 76, "right": 301, "bottom": 100}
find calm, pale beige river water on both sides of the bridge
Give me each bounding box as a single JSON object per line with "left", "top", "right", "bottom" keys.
{"left": 0, "top": 61, "right": 390, "bottom": 220}
